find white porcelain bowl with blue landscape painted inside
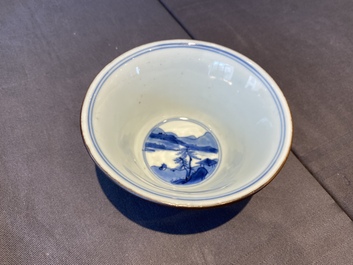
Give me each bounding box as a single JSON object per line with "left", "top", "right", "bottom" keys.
{"left": 81, "top": 40, "right": 292, "bottom": 207}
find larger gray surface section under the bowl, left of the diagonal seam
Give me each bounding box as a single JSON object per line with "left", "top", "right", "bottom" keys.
{"left": 0, "top": 0, "right": 353, "bottom": 265}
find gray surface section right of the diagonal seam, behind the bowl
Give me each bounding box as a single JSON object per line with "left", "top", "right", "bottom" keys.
{"left": 163, "top": 0, "right": 353, "bottom": 218}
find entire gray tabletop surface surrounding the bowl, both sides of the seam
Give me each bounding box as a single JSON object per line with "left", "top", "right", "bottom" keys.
{"left": 0, "top": 0, "right": 353, "bottom": 264}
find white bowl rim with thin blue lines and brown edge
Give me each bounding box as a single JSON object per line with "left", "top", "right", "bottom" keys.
{"left": 80, "top": 39, "right": 293, "bottom": 208}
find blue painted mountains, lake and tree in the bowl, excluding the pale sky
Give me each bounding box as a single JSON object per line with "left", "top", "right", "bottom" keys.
{"left": 144, "top": 128, "right": 219, "bottom": 185}
